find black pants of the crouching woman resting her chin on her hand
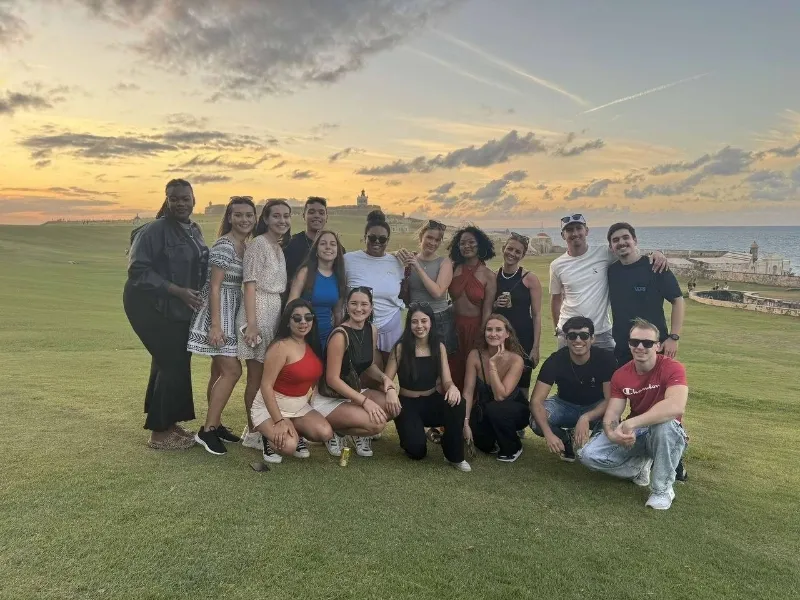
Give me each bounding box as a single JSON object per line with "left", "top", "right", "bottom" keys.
{"left": 469, "top": 390, "right": 531, "bottom": 456}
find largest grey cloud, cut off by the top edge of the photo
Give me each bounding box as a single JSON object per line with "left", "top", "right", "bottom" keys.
{"left": 72, "top": 0, "right": 463, "bottom": 98}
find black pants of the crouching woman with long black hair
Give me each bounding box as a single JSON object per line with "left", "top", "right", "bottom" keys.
{"left": 394, "top": 392, "right": 466, "bottom": 462}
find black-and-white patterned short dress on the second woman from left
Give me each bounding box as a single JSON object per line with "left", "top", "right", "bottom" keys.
{"left": 186, "top": 237, "right": 243, "bottom": 357}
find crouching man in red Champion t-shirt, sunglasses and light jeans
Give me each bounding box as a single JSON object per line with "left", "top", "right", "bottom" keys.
{"left": 579, "top": 319, "right": 689, "bottom": 510}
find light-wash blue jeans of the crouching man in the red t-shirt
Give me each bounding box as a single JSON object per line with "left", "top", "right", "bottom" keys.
{"left": 578, "top": 420, "right": 688, "bottom": 494}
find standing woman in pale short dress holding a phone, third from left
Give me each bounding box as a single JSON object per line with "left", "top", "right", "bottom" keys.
{"left": 236, "top": 200, "right": 292, "bottom": 449}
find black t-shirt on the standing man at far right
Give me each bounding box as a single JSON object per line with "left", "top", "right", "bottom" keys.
{"left": 608, "top": 256, "right": 682, "bottom": 348}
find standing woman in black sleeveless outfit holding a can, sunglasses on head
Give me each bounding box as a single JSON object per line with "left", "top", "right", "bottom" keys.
{"left": 494, "top": 233, "right": 542, "bottom": 398}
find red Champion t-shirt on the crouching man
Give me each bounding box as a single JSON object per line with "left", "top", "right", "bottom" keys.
{"left": 611, "top": 354, "right": 686, "bottom": 420}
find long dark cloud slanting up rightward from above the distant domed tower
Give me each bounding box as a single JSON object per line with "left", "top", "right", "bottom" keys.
{"left": 356, "top": 130, "right": 547, "bottom": 175}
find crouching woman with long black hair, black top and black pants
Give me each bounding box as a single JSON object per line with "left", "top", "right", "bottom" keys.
{"left": 386, "top": 302, "right": 472, "bottom": 472}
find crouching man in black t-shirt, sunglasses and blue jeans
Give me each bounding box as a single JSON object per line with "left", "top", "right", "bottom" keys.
{"left": 530, "top": 317, "right": 617, "bottom": 462}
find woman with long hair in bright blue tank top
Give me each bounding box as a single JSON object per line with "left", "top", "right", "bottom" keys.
{"left": 288, "top": 230, "right": 347, "bottom": 349}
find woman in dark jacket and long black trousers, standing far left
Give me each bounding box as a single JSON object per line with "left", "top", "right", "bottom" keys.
{"left": 122, "top": 179, "right": 208, "bottom": 450}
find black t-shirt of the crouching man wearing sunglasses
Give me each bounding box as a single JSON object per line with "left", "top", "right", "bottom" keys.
{"left": 538, "top": 347, "right": 617, "bottom": 406}
